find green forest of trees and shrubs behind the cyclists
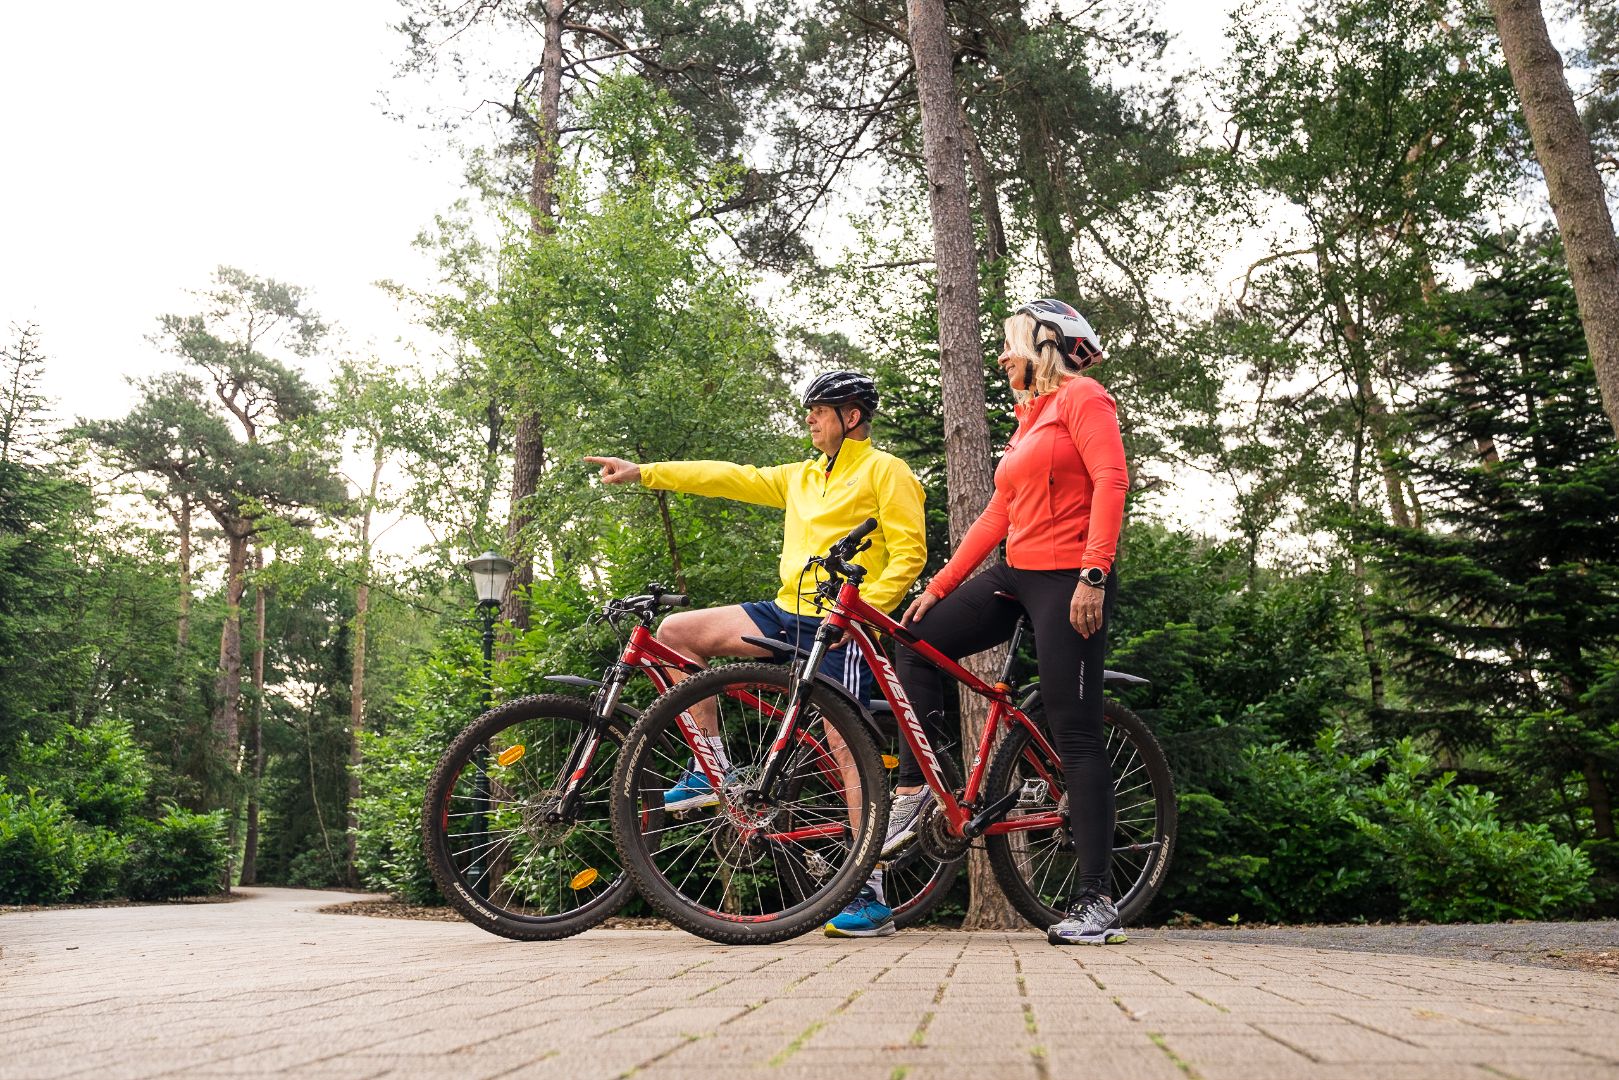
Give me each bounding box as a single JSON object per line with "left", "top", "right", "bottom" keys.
{"left": 0, "top": 0, "right": 1619, "bottom": 921}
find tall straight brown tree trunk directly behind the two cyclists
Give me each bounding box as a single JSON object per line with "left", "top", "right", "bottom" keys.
{"left": 907, "top": 0, "right": 1022, "bottom": 929}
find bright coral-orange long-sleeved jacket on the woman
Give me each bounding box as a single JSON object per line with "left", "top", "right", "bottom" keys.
{"left": 928, "top": 376, "right": 1130, "bottom": 597}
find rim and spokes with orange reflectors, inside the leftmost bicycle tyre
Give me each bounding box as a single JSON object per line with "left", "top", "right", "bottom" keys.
{"left": 437, "top": 717, "right": 625, "bottom": 921}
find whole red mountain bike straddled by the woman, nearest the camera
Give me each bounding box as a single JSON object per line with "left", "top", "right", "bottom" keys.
{"left": 612, "top": 520, "right": 1175, "bottom": 944}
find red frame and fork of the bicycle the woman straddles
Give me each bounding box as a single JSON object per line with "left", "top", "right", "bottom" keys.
{"left": 758, "top": 581, "right": 1062, "bottom": 839}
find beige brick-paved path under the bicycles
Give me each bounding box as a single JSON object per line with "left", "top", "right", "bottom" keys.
{"left": 0, "top": 889, "right": 1619, "bottom": 1080}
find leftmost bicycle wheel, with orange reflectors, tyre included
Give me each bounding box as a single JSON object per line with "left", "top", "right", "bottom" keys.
{"left": 421, "top": 695, "right": 630, "bottom": 941}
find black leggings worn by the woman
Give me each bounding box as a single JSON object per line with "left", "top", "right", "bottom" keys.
{"left": 897, "top": 565, "right": 1115, "bottom": 895}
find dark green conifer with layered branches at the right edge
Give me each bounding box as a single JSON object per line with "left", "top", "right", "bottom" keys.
{"left": 1363, "top": 238, "right": 1619, "bottom": 861}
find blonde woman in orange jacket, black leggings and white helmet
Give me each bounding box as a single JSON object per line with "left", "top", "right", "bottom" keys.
{"left": 884, "top": 300, "right": 1128, "bottom": 946}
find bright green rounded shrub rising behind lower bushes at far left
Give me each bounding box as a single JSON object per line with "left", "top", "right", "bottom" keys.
{"left": 13, "top": 717, "right": 152, "bottom": 829}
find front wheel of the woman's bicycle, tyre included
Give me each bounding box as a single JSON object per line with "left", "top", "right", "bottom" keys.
{"left": 612, "top": 664, "right": 889, "bottom": 946}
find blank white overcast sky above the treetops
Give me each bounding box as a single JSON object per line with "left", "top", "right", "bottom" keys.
{"left": 0, "top": 0, "right": 1229, "bottom": 430}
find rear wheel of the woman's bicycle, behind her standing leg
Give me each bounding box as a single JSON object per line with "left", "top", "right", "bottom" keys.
{"left": 984, "top": 701, "right": 1175, "bottom": 926}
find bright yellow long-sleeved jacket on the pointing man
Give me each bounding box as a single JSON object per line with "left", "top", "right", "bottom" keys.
{"left": 641, "top": 439, "right": 928, "bottom": 615}
